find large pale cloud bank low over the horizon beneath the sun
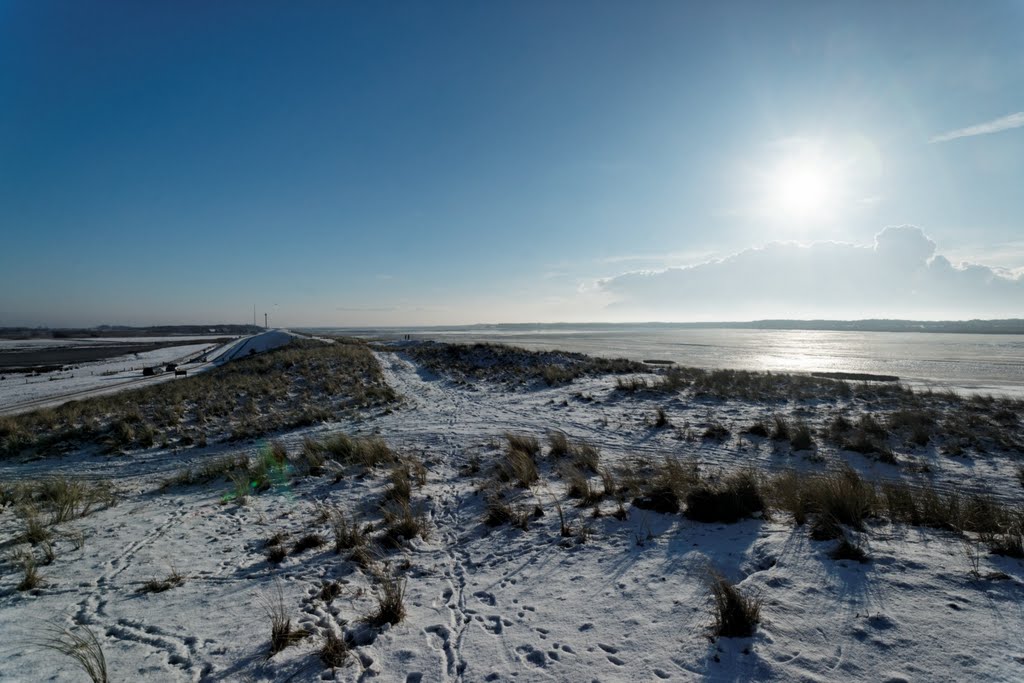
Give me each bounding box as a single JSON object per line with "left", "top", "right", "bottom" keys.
{"left": 597, "top": 225, "right": 1024, "bottom": 321}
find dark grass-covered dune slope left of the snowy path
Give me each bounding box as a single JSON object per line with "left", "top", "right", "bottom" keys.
{"left": 0, "top": 339, "right": 396, "bottom": 457}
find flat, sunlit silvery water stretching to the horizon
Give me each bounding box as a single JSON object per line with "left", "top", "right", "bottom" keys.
{"left": 325, "top": 325, "right": 1024, "bottom": 396}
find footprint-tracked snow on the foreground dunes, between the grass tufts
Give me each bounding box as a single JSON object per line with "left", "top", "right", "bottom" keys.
{"left": 0, "top": 352, "right": 1024, "bottom": 682}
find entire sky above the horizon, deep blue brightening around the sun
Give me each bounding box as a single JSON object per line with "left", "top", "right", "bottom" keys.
{"left": 0, "top": 0, "right": 1024, "bottom": 326}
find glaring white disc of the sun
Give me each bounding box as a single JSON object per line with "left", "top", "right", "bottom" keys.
{"left": 770, "top": 157, "right": 839, "bottom": 219}
